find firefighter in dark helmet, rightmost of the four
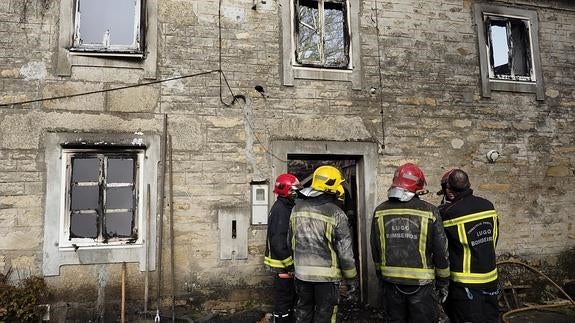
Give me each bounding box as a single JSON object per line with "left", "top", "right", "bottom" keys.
{"left": 439, "top": 169, "right": 499, "bottom": 323}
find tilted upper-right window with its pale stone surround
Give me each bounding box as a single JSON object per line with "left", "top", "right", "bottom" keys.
{"left": 475, "top": 4, "right": 544, "bottom": 100}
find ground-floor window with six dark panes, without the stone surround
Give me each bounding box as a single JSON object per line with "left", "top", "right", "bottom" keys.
{"left": 65, "top": 150, "right": 140, "bottom": 243}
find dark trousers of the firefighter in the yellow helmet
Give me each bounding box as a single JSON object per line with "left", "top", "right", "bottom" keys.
{"left": 295, "top": 278, "right": 339, "bottom": 323}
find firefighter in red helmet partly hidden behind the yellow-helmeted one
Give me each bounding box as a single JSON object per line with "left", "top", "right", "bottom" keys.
{"left": 264, "top": 173, "right": 301, "bottom": 323}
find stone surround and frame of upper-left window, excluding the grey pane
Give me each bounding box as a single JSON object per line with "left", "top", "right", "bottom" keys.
{"left": 56, "top": 0, "right": 159, "bottom": 79}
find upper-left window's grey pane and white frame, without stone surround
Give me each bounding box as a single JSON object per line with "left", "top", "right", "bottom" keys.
{"left": 71, "top": 0, "right": 143, "bottom": 54}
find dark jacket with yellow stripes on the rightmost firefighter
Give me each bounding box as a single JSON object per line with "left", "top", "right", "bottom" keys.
{"left": 439, "top": 189, "right": 499, "bottom": 288}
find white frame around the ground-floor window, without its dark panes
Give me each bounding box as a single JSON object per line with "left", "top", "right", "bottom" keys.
{"left": 59, "top": 149, "right": 145, "bottom": 248}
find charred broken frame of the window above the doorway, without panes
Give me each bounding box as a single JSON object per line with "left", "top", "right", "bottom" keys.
{"left": 292, "top": 0, "right": 351, "bottom": 69}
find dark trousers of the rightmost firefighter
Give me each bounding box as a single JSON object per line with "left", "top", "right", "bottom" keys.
{"left": 443, "top": 283, "right": 499, "bottom": 323}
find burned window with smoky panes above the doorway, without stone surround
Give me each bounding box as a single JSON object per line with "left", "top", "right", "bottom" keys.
{"left": 294, "top": 0, "right": 350, "bottom": 68}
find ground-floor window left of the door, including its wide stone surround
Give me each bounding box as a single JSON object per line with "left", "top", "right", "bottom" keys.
{"left": 42, "top": 132, "right": 161, "bottom": 276}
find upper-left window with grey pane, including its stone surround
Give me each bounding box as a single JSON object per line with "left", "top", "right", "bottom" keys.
{"left": 57, "top": 0, "right": 159, "bottom": 79}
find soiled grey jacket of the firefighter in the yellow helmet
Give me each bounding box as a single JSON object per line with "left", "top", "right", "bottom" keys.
{"left": 288, "top": 194, "right": 357, "bottom": 282}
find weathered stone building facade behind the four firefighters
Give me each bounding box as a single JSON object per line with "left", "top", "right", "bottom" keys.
{"left": 0, "top": 0, "right": 575, "bottom": 316}
